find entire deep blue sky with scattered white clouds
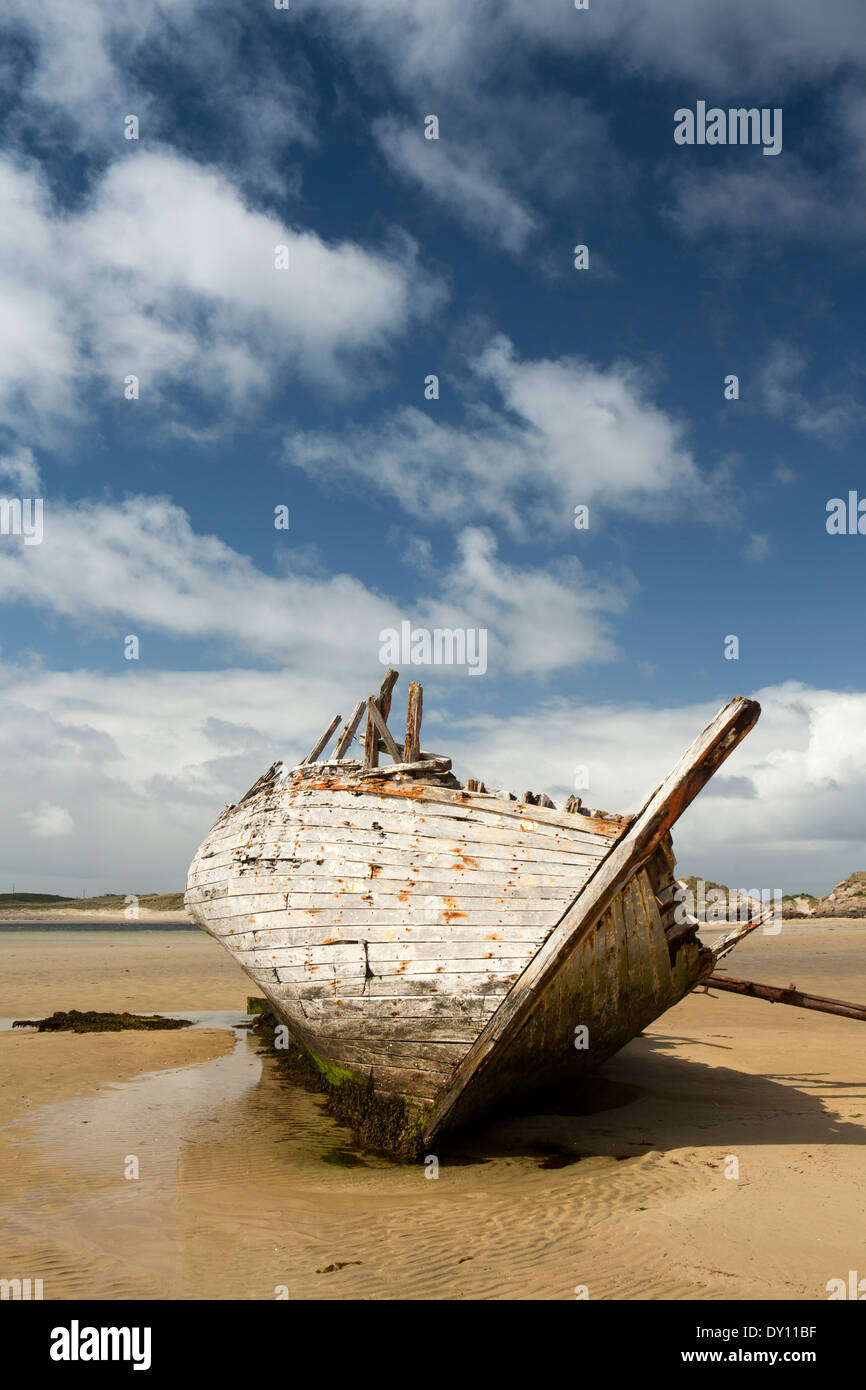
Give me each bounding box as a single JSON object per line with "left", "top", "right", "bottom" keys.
{"left": 0, "top": 0, "right": 866, "bottom": 894}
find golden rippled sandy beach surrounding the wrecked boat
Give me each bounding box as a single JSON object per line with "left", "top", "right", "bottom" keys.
{"left": 0, "top": 922, "right": 866, "bottom": 1300}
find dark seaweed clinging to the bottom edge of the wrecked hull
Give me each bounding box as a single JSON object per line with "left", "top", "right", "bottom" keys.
{"left": 250, "top": 1012, "right": 424, "bottom": 1162}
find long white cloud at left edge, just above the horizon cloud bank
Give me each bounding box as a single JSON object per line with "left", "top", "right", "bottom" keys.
{"left": 0, "top": 498, "right": 393, "bottom": 664}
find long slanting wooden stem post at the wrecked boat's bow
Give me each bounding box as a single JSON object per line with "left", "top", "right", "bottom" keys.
{"left": 424, "top": 696, "right": 760, "bottom": 1143}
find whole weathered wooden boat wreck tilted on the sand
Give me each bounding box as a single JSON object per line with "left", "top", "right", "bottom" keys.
{"left": 186, "top": 670, "right": 760, "bottom": 1154}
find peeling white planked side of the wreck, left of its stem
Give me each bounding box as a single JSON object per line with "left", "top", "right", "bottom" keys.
{"left": 186, "top": 769, "right": 623, "bottom": 1105}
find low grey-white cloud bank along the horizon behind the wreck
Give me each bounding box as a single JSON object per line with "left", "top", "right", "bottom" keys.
{"left": 0, "top": 663, "right": 866, "bottom": 892}
